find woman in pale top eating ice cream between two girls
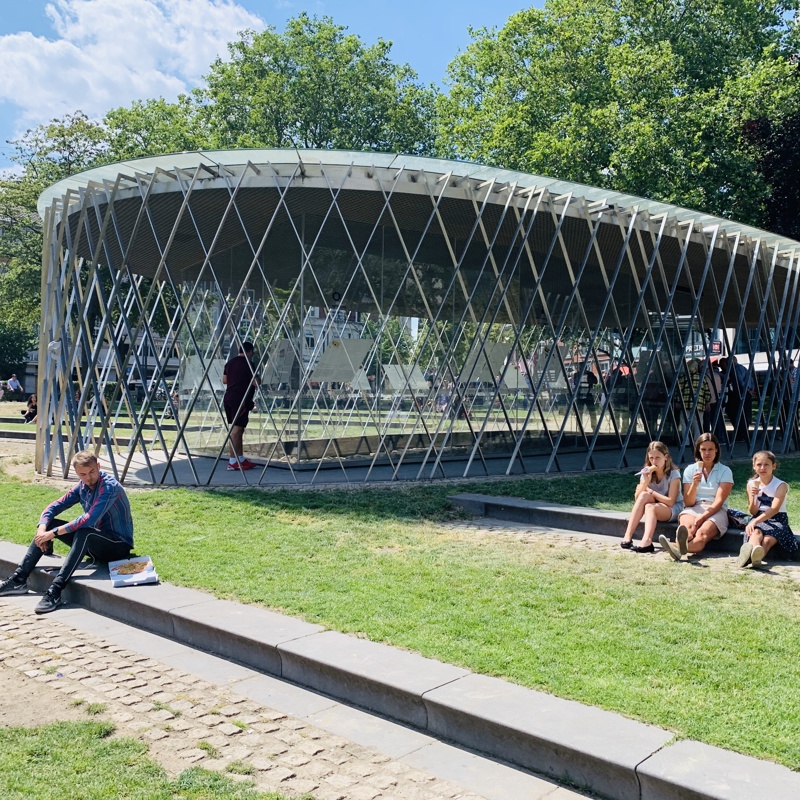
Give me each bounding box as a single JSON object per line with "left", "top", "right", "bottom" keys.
{"left": 658, "top": 433, "right": 733, "bottom": 561}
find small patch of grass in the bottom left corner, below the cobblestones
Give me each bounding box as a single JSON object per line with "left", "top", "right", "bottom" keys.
{"left": 0, "top": 722, "right": 281, "bottom": 800}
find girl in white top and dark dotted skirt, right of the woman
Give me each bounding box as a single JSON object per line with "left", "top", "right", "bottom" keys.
{"left": 736, "top": 450, "right": 797, "bottom": 567}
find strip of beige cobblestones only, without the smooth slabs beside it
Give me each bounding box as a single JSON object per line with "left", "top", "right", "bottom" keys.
{"left": 0, "top": 600, "right": 488, "bottom": 800}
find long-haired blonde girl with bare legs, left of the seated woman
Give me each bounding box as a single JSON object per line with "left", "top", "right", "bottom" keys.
{"left": 620, "top": 442, "right": 683, "bottom": 553}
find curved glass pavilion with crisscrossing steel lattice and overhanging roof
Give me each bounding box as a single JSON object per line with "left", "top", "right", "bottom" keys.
{"left": 36, "top": 150, "right": 800, "bottom": 485}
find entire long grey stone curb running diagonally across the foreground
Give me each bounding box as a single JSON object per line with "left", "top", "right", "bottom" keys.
{"left": 0, "top": 542, "right": 800, "bottom": 800}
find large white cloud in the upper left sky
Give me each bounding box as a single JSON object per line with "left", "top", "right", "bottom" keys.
{"left": 0, "top": 0, "right": 264, "bottom": 135}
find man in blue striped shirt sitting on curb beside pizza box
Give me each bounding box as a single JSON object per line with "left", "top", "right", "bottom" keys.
{"left": 0, "top": 450, "right": 133, "bottom": 614}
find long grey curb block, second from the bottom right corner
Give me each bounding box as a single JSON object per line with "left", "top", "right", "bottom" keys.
{"left": 425, "top": 675, "right": 673, "bottom": 800}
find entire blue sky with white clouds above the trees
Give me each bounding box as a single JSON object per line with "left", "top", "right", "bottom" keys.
{"left": 0, "top": 0, "right": 541, "bottom": 169}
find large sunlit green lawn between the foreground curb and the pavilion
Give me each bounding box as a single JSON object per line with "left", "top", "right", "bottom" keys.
{"left": 0, "top": 459, "right": 800, "bottom": 769}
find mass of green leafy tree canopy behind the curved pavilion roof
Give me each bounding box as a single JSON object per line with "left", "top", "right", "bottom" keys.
{"left": 0, "top": 0, "right": 800, "bottom": 354}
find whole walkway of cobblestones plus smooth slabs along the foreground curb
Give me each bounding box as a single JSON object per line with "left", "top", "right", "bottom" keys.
{"left": 0, "top": 594, "right": 589, "bottom": 800}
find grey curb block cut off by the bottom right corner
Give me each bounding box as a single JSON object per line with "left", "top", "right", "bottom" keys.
{"left": 638, "top": 740, "right": 800, "bottom": 800}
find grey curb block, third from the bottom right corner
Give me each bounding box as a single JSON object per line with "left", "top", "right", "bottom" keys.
{"left": 278, "top": 631, "right": 470, "bottom": 730}
